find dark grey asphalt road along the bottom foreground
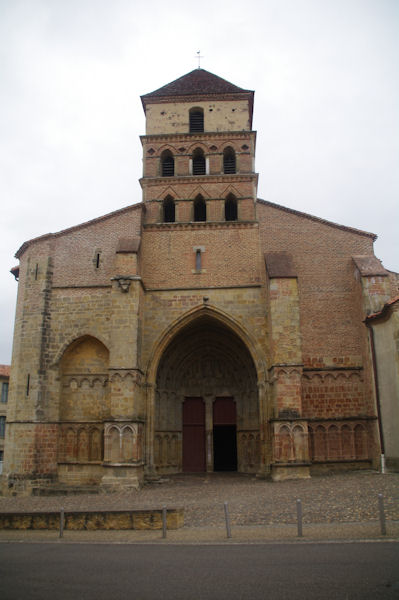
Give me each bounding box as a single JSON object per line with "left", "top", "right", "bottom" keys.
{"left": 0, "top": 542, "right": 399, "bottom": 600}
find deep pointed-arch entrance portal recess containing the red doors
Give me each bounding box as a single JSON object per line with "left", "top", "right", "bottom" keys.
{"left": 154, "top": 315, "right": 260, "bottom": 473}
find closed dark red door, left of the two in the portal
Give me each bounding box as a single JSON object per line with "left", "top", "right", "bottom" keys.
{"left": 183, "top": 398, "right": 206, "bottom": 473}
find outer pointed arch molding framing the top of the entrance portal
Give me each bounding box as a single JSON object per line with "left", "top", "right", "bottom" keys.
{"left": 146, "top": 302, "right": 267, "bottom": 384}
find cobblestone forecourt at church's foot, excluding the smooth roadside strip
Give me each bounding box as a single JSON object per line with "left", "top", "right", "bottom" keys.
{"left": 0, "top": 471, "right": 399, "bottom": 527}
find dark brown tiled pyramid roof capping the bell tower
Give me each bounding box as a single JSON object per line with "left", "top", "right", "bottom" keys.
{"left": 141, "top": 69, "right": 253, "bottom": 105}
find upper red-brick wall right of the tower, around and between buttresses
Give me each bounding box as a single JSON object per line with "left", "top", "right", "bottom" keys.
{"left": 257, "top": 203, "right": 373, "bottom": 367}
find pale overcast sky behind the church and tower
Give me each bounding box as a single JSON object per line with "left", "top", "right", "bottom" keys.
{"left": 0, "top": 0, "right": 399, "bottom": 363}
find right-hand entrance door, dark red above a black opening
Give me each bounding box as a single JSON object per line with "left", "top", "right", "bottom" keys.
{"left": 213, "top": 398, "right": 237, "bottom": 471}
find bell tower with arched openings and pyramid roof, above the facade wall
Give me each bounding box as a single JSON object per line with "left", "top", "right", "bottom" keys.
{"left": 140, "top": 68, "right": 257, "bottom": 225}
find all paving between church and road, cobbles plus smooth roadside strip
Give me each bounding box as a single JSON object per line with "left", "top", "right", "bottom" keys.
{"left": 0, "top": 471, "right": 399, "bottom": 543}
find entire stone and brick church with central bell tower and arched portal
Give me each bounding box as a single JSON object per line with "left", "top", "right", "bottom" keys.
{"left": 3, "top": 69, "right": 396, "bottom": 494}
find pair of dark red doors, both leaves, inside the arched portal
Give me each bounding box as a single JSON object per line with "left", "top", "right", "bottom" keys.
{"left": 183, "top": 397, "right": 237, "bottom": 473}
